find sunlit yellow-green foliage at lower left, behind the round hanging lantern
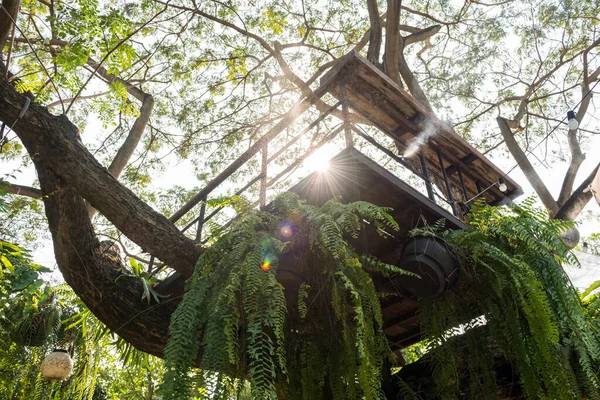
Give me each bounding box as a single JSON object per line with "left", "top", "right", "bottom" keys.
{"left": 0, "top": 236, "right": 162, "bottom": 400}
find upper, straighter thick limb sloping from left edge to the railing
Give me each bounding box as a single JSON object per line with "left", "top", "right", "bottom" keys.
{"left": 0, "top": 65, "right": 201, "bottom": 276}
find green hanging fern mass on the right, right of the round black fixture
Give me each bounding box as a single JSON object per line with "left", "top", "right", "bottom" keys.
{"left": 418, "top": 199, "right": 600, "bottom": 399}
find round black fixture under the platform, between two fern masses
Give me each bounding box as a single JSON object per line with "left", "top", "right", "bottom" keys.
{"left": 398, "top": 236, "right": 460, "bottom": 299}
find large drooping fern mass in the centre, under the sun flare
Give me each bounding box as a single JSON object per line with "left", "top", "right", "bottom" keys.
{"left": 163, "top": 193, "right": 410, "bottom": 399}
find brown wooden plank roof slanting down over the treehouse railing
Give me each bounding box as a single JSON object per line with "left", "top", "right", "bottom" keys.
{"left": 320, "top": 51, "right": 523, "bottom": 204}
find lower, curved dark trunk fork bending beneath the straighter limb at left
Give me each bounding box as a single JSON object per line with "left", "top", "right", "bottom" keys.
{"left": 33, "top": 155, "right": 179, "bottom": 357}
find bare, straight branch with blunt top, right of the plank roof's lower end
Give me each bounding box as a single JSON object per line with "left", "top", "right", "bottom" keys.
{"left": 496, "top": 117, "right": 558, "bottom": 215}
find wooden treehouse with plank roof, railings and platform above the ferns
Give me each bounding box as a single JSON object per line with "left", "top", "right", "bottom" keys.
{"left": 157, "top": 52, "right": 522, "bottom": 349}
